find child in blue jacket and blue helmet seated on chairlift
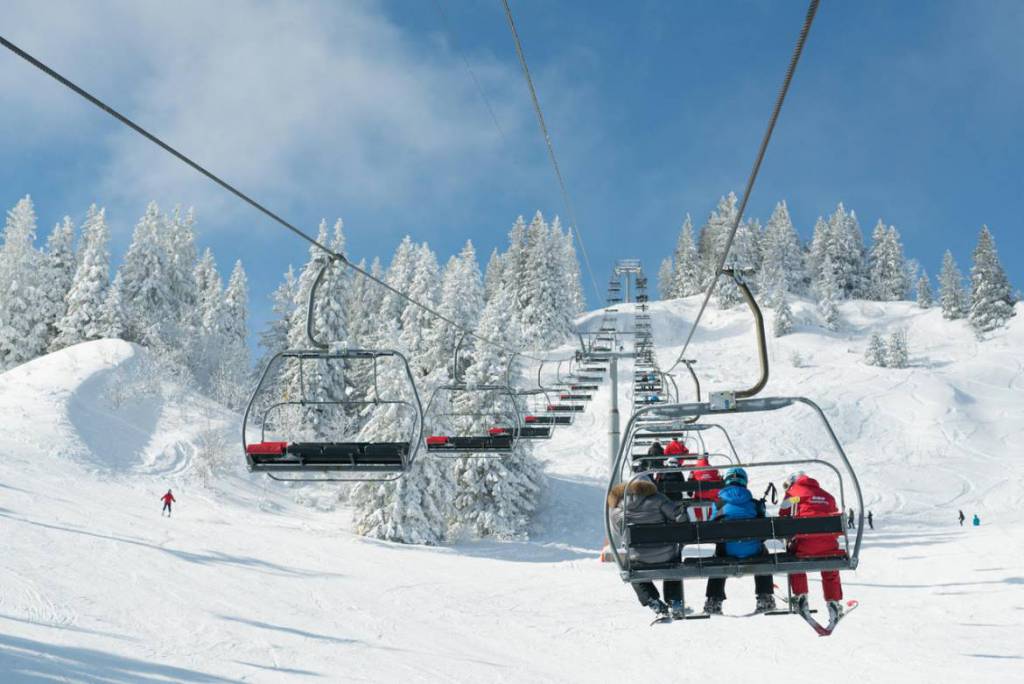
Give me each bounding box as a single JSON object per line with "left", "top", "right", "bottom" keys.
{"left": 705, "top": 468, "right": 775, "bottom": 614}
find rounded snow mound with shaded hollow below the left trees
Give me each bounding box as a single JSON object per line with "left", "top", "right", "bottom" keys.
{"left": 0, "top": 340, "right": 239, "bottom": 476}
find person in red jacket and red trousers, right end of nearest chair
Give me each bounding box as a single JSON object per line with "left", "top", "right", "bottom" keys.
{"left": 778, "top": 471, "right": 843, "bottom": 623}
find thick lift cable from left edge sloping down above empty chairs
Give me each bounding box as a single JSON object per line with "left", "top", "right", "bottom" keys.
{"left": 0, "top": 36, "right": 573, "bottom": 361}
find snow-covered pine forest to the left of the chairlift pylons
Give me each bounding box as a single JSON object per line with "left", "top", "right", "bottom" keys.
{"left": 0, "top": 197, "right": 585, "bottom": 544}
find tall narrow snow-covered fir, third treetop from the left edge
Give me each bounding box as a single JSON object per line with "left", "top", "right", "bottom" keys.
{"left": 50, "top": 205, "right": 111, "bottom": 349}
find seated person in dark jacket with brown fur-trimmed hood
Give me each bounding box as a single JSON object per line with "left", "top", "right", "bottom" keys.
{"left": 608, "top": 476, "right": 686, "bottom": 619}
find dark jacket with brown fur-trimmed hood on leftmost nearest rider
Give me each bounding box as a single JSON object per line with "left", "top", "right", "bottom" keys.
{"left": 608, "top": 477, "right": 686, "bottom": 563}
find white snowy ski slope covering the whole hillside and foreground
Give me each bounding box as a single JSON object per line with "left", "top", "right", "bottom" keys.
{"left": 0, "top": 300, "right": 1024, "bottom": 683}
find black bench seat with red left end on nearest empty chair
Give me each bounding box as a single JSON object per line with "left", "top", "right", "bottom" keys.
{"left": 246, "top": 441, "right": 409, "bottom": 472}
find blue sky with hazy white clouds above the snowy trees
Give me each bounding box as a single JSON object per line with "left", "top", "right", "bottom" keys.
{"left": 0, "top": 0, "right": 1024, "bottom": 348}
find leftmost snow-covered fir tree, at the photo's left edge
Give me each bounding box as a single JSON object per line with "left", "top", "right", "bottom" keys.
{"left": 0, "top": 196, "right": 49, "bottom": 370}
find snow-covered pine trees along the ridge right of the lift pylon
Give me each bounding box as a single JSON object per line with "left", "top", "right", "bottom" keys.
{"left": 658, "top": 193, "right": 1020, "bottom": 337}
